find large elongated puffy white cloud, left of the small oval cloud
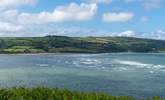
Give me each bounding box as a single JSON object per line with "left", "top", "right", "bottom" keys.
{"left": 14, "top": 3, "right": 97, "bottom": 24}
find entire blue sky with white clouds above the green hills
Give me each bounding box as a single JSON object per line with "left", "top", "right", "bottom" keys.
{"left": 0, "top": 0, "right": 165, "bottom": 40}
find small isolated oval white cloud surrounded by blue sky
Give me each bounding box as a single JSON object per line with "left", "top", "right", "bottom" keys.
{"left": 102, "top": 12, "right": 134, "bottom": 22}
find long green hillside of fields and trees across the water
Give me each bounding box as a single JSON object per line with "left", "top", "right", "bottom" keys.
{"left": 0, "top": 36, "right": 165, "bottom": 53}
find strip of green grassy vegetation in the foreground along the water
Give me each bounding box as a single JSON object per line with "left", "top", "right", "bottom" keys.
{"left": 0, "top": 87, "right": 165, "bottom": 100}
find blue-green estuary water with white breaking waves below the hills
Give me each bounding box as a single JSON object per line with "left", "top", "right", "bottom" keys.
{"left": 0, "top": 53, "right": 165, "bottom": 97}
